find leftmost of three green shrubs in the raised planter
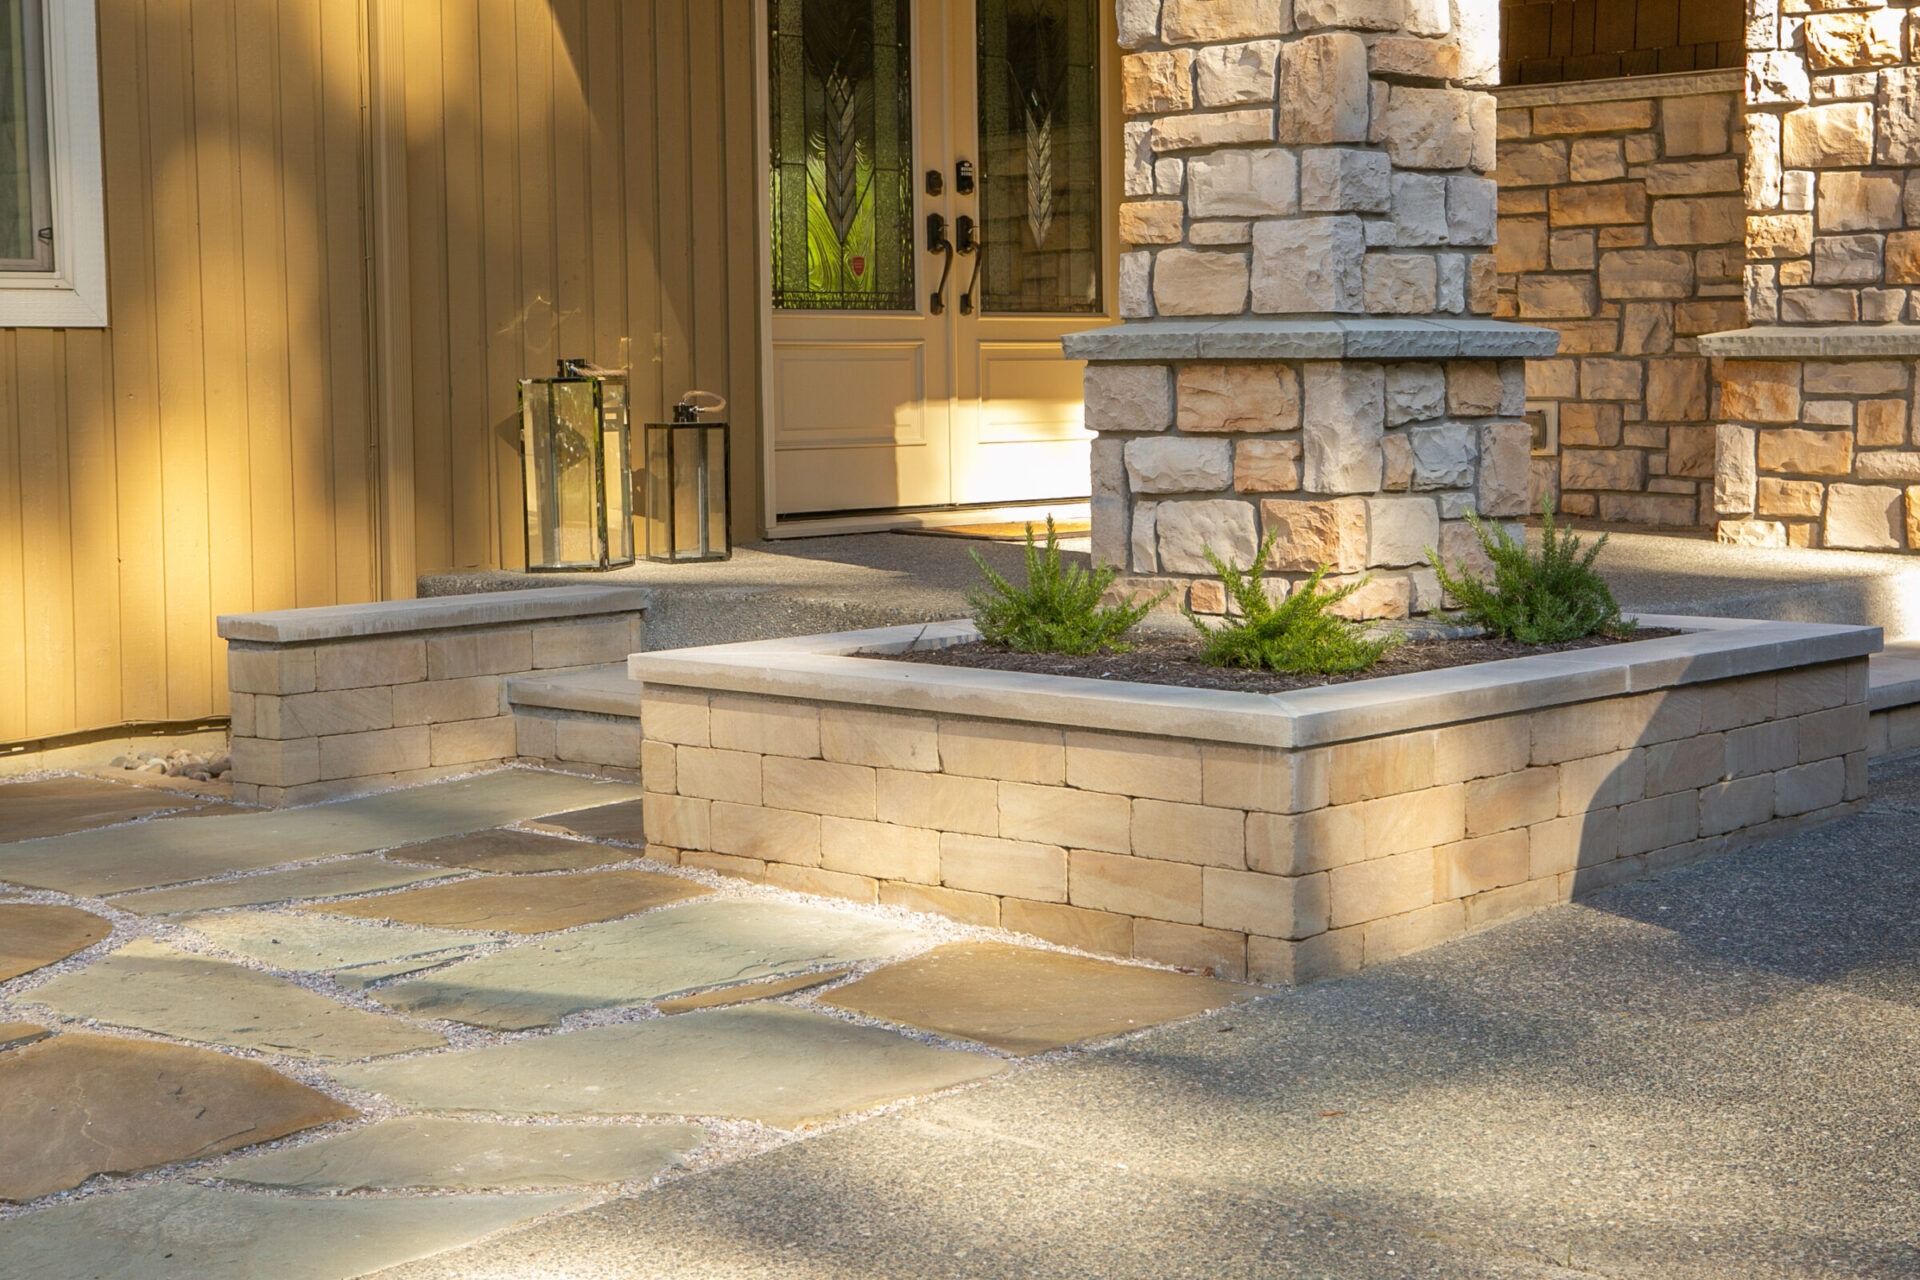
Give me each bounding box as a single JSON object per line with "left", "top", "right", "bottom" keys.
{"left": 968, "top": 516, "right": 1167, "bottom": 654}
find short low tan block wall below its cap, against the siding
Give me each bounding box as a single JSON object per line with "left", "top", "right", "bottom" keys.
{"left": 227, "top": 606, "right": 641, "bottom": 806}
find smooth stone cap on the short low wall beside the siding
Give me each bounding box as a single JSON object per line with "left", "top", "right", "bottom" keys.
{"left": 219, "top": 587, "right": 653, "bottom": 645}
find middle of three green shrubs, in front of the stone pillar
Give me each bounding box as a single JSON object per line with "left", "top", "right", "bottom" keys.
{"left": 1187, "top": 533, "right": 1400, "bottom": 676}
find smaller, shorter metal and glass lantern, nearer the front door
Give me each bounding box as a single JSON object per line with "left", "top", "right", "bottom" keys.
{"left": 647, "top": 391, "right": 733, "bottom": 562}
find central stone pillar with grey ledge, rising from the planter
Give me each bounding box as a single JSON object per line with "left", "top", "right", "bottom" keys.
{"left": 1066, "top": 0, "right": 1559, "bottom": 616}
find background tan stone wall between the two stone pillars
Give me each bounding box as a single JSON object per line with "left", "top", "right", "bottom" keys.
{"left": 1494, "top": 71, "right": 1747, "bottom": 528}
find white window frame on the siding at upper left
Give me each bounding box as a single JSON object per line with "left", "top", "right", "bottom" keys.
{"left": 0, "top": 0, "right": 108, "bottom": 328}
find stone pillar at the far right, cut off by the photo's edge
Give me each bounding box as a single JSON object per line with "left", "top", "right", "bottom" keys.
{"left": 1701, "top": 0, "right": 1920, "bottom": 551}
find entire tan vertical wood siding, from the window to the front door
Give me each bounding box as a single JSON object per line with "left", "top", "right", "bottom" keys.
{"left": 0, "top": 0, "right": 762, "bottom": 745}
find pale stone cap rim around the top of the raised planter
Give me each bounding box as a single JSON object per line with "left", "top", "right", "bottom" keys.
{"left": 628, "top": 614, "right": 1882, "bottom": 747}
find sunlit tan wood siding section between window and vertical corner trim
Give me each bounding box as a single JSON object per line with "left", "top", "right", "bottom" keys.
{"left": 0, "top": 0, "right": 376, "bottom": 743}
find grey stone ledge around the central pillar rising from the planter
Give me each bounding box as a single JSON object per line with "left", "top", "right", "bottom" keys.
{"left": 1060, "top": 317, "right": 1559, "bottom": 361}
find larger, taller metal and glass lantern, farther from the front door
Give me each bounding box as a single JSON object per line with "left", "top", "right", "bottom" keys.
{"left": 520, "top": 361, "right": 634, "bottom": 570}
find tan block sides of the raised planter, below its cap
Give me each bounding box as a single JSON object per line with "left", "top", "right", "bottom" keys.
{"left": 641, "top": 660, "right": 1868, "bottom": 983}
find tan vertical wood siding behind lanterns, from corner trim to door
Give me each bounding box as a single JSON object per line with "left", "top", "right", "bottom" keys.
{"left": 399, "top": 0, "right": 764, "bottom": 570}
